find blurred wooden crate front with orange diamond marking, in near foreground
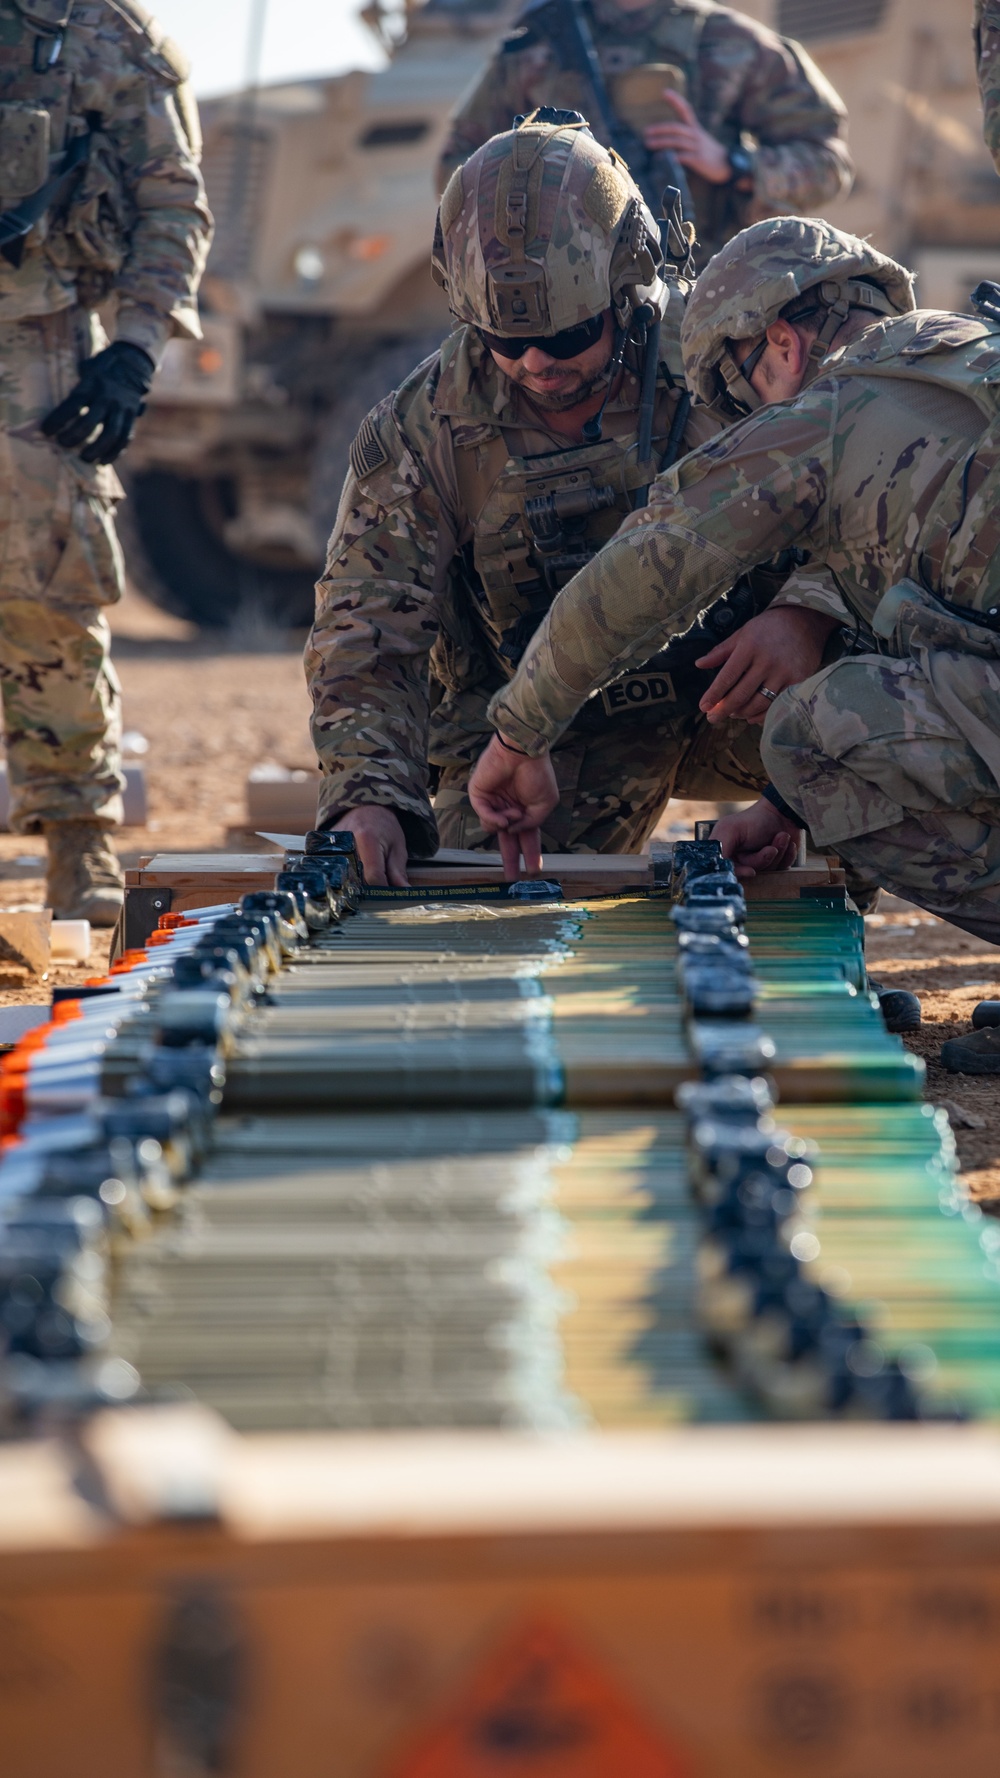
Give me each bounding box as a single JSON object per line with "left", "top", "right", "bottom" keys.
{"left": 0, "top": 1410, "right": 1000, "bottom": 1778}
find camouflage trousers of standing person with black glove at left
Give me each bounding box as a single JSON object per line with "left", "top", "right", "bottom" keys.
{"left": 0, "top": 309, "right": 125, "bottom": 834}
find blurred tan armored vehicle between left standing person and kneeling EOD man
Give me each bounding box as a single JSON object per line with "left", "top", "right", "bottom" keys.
{"left": 128, "top": 0, "right": 509, "bottom": 624}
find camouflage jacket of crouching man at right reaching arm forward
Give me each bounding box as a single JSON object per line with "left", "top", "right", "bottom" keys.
{"left": 491, "top": 309, "right": 1000, "bottom": 754}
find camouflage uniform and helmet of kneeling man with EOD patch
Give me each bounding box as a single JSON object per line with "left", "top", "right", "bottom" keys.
{"left": 306, "top": 118, "right": 765, "bottom": 855}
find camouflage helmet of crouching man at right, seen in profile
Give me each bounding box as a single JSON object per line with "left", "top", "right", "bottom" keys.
{"left": 680, "top": 217, "right": 915, "bottom": 412}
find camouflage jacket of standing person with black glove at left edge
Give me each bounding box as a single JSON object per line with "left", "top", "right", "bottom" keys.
{"left": 0, "top": 0, "right": 212, "bottom": 361}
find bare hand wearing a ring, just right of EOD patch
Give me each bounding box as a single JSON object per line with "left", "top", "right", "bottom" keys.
{"left": 696, "top": 605, "right": 836, "bottom": 724}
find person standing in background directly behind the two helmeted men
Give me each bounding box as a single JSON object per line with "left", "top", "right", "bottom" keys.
{"left": 440, "top": 0, "right": 852, "bottom": 263}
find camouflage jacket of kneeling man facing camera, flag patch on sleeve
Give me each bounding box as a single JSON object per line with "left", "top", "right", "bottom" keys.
{"left": 306, "top": 316, "right": 717, "bottom": 853}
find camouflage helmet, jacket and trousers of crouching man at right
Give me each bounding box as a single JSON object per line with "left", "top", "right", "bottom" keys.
{"left": 491, "top": 224, "right": 1000, "bottom": 941}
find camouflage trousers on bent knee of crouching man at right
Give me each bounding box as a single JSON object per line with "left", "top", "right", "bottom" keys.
{"left": 762, "top": 651, "right": 1000, "bottom": 944}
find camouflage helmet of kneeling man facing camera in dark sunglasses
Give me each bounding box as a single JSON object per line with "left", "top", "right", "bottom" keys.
{"left": 431, "top": 114, "right": 667, "bottom": 340}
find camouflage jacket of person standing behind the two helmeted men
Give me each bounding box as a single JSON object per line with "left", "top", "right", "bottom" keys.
{"left": 440, "top": 0, "right": 852, "bottom": 265}
